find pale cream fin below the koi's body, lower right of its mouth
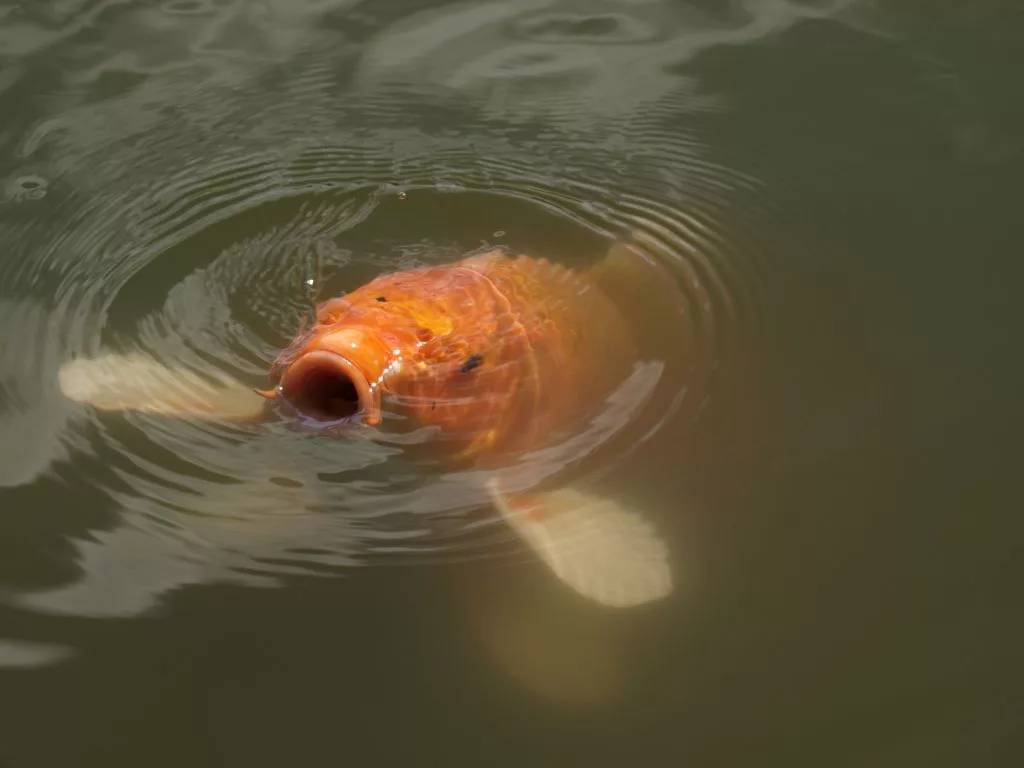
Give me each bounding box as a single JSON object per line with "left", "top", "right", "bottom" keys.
{"left": 487, "top": 479, "right": 673, "bottom": 607}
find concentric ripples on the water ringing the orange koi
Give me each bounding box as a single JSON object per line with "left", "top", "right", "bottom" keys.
{"left": 0, "top": 3, "right": 823, "bottom": 614}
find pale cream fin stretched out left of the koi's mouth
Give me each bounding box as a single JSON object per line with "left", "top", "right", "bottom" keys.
{"left": 58, "top": 354, "right": 266, "bottom": 421}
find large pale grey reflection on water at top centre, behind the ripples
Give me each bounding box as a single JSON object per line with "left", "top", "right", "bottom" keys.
{"left": 356, "top": 0, "right": 850, "bottom": 123}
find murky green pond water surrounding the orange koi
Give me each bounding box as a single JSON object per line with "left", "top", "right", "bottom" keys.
{"left": 0, "top": 0, "right": 1024, "bottom": 768}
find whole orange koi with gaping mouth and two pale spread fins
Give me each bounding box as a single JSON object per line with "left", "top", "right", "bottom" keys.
{"left": 60, "top": 239, "right": 673, "bottom": 606}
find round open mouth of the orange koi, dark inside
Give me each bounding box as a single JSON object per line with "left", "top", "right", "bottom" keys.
{"left": 281, "top": 350, "right": 380, "bottom": 425}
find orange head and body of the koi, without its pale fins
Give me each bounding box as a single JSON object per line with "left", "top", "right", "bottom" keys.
{"left": 273, "top": 251, "right": 636, "bottom": 457}
